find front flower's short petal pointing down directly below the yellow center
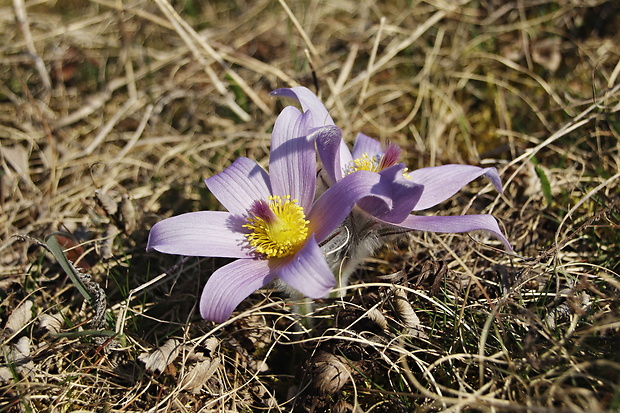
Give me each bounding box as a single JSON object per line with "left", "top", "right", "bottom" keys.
{"left": 274, "top": 236, "right": 336, "bottom": 298}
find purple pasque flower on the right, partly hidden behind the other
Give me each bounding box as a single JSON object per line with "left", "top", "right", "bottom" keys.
{"left": 272, "top": 87, "right": 512, "bottom": 250}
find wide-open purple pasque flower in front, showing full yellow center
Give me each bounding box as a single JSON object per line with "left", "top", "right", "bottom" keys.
{"left": 147, "top": 107, "right": 392, "bottom": 322}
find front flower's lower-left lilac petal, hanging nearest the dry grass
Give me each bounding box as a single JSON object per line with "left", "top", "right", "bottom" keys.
{"left": 200, "top": 259, "right": 275, "bottom": 323}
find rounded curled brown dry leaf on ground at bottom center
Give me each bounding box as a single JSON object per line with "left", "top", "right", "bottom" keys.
{"left": 311, "top": 351, "right": 351, "bottom": 394}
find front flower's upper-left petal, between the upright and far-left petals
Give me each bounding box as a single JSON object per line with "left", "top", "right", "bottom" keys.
{"left": 205, "top": 157, "right": 271, "bottom": 215}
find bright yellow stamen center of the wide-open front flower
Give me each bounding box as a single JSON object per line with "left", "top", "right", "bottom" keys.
{"left": 243, "top": 195, "right": 310, "bottom": 258}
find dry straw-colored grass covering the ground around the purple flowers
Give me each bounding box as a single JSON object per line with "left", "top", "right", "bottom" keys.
{"left": 0, "top": 0, "right": 620, "bottom": 412}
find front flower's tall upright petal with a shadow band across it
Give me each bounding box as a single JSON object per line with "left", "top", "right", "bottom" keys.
{"left": 269, "top": 106, "right": 316, "bottom": 211}
